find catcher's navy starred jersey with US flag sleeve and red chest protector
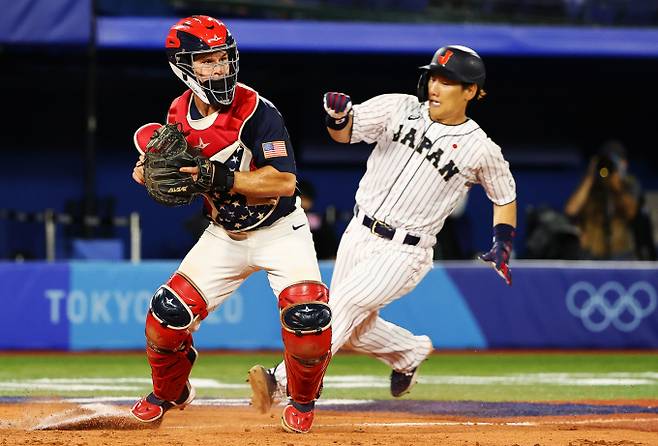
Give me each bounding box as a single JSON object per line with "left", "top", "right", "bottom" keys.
{"left": 167, "top": 84, "right": 296, "bottom": 232}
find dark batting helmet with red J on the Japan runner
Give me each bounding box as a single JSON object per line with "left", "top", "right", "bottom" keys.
{"left": 417, "top": 45, "right": 486, "bottom": 102}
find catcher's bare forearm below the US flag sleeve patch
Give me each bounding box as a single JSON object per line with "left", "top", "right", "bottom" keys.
{"left": 231, "top": 166, "right": 296, "bottom": 197}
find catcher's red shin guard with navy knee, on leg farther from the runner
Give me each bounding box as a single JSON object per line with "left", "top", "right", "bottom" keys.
{"left": 146, "top": 273, "right": 208, "bottom": 401}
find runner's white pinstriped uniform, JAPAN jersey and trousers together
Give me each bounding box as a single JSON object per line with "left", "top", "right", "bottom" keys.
{"left": 274, "top": 94, "right": 516, "bottom": 386}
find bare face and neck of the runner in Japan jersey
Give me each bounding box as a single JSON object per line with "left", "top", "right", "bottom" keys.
{"left": 427, "top": 74, "right": 477, "bottom": 125}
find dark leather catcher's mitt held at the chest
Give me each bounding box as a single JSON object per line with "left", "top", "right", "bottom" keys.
{"left": 144, "top": 123, "right": 214, "bottom": 206}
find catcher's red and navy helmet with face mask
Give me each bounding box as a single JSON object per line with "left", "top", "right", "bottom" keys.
{"left": 165, "top": 15, "right": 240, "bottom": 105}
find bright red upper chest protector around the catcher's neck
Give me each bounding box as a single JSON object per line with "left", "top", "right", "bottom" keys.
{"left": 167, "top": 84, "right": 258, "bottom": 158}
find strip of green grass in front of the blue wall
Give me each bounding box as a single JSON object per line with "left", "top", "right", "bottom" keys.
{"left": 0, "top": 352, "right": 658, "bottom": 401}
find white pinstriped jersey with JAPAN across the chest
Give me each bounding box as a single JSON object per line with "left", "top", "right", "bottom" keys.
{"left": 350, "top": 94, "right": 516, "bottom": 235}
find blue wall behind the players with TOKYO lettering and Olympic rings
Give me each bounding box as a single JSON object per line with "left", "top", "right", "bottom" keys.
{"left": 0, "top": 261, "right": 658, "bottom": 351}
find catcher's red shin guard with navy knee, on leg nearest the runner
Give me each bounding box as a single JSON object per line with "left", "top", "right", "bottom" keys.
{"left": 279, "top": 281, "right": 331, "bottom": 404}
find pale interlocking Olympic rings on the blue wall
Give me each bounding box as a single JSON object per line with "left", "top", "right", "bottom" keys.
{"left": 566, "top": 281, "right": 658, "bottom": 332}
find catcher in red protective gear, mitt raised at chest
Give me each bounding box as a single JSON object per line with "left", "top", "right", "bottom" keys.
{"left": 130, "top": 15, "right": 332, "bottom": 433}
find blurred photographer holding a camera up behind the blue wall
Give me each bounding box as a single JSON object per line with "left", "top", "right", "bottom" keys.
{"left": 564, "top": 140, "right": 642, "bottom": 260}
